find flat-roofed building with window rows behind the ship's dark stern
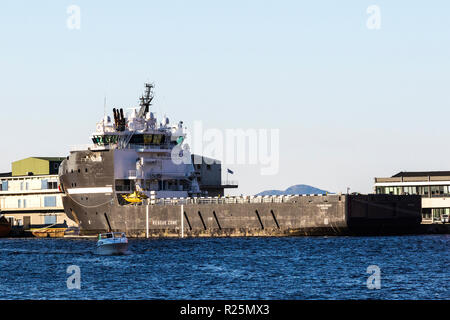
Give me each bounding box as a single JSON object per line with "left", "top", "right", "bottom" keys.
{"left": 374, "top": 171, "right": 450, "bottom": 223}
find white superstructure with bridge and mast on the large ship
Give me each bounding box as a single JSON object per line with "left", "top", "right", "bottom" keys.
{"left": 78, "top": 84, "right": 201, "bottom": 198}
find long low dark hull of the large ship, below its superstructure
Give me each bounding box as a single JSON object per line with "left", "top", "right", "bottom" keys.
{"left": 63, "top": 195, "right": 421, "bottom": 238}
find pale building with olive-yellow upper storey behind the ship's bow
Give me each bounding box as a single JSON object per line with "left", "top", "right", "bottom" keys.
{"left": 0, "top": 157, "right": 76, "bottom": 229}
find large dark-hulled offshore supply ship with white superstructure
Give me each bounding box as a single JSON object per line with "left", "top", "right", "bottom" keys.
{"left": 59, "top": 84, "right": 421, "bottom": 237}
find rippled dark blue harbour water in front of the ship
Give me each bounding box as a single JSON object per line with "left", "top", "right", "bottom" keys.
{"left": 0, "top": 235, "right": 450, "bottom": 299}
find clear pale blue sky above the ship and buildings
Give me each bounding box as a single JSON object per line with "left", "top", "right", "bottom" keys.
{"left": 0, "top": 0, "right": 450, "bottom": 193}
